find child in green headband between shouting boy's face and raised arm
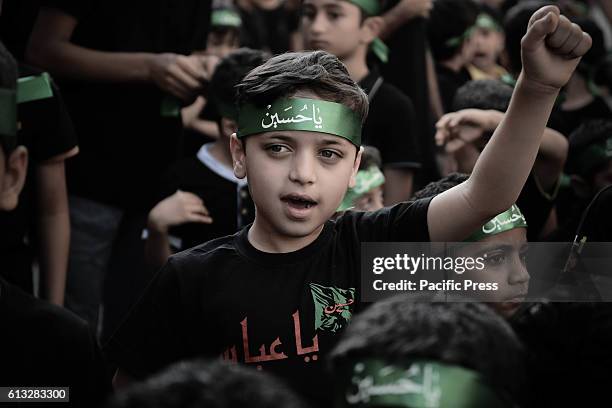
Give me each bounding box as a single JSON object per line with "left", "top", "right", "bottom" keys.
{"left": 338, "top": 146, "right": 385, "bottom": 212}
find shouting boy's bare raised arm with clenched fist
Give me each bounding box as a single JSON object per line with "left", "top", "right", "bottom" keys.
{"left": 427, "top": 6, "right": 591, "bottom": 241}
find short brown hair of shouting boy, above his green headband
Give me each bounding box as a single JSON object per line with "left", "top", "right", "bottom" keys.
{"left": 237, "top": 51, "right": 368, "bottom": 123}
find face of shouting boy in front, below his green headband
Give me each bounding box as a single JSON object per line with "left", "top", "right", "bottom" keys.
{"left": 230, "top": 116, "right": 361, "bottom": 239}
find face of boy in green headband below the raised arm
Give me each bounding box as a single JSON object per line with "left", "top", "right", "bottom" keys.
{"left": 465, "top": 228, "right": 530, "bottom": 317}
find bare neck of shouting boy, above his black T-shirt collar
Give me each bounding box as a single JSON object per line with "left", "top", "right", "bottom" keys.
{"left": 248, "top": 220, "right": 324, "bottom": 254}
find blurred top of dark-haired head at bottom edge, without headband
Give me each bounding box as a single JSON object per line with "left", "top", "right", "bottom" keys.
{"left": 109, "top": 361, "right": 305, "bottom": 408}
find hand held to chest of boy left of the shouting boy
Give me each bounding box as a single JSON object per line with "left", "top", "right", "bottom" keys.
{"left": 148, "top": 190, "right": 213, "bottom": 233}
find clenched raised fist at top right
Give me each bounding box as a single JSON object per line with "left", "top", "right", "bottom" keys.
{"left": 521, "top": 6, "right": 592, "bottom": 92}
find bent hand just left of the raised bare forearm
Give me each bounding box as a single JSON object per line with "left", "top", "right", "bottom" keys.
{"left": 435, "top": 109, "right": 504, "bottom": 153}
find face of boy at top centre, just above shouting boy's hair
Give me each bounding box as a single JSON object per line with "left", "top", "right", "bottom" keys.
{"left": 302, "top": 0, "right": 372, "bottom": 60}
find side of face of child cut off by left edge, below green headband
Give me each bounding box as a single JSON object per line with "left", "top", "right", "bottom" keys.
{"left": 0, "top": 146, "right": 28, "bottom": 211}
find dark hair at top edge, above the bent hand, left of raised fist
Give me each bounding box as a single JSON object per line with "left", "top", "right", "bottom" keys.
{"left": 427, "top": 0, "right": 478, "bottom": 61}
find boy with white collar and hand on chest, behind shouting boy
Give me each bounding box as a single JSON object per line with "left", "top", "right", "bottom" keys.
{"left": 145, "top": 48, "right": 267, "bottom": 268}
